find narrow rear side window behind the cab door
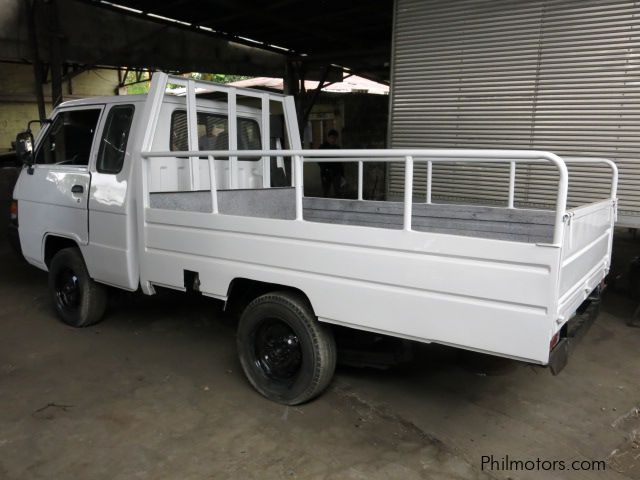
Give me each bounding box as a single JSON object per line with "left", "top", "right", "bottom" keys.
{"left": 96, "top": 105, "right": 135, "bottom": 173}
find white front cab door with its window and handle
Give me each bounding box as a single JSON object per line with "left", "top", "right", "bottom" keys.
{"left": 14, "top": 105, "right": 103, "bottom": 268}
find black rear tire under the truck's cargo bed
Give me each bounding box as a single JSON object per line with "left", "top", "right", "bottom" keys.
{"left": 237, "top": 292, "right": 336, "bottom": 405}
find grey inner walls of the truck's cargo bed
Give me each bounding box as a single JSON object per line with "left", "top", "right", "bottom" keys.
{"left": 150, "top": 188, "right": 554, "bottom": 243}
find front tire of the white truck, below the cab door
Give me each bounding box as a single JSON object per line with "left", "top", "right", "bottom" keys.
{"left": 49, "top": 248, "right": 107, "bottom": 327}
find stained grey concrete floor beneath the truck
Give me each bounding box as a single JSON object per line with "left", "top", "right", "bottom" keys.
{"left": 0, "top": 234, "right": 640, "bottom": 480}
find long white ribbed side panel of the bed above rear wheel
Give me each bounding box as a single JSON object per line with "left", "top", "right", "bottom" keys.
{"left": 144, "top": 209, "right": 559, "bottom": 363}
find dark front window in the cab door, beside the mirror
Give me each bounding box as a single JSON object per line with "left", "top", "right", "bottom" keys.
{"left": 36, "top": 109, "right": 100, "bottom": 165}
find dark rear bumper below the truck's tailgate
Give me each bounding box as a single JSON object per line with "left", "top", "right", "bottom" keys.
{"left": 549, "top": 287, "right": 601, "bottom": 375}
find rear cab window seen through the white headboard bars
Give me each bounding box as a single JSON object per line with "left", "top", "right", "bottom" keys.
{"left": 169, "top": 110, "right": 262, "bottom": 160}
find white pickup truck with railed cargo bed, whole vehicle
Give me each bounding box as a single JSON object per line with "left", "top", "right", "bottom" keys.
{"left": 14, "top": 73, "right": 617, "bottom": 405}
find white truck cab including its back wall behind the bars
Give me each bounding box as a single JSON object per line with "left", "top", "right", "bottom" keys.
{"left": 14, "top": 95, "right": 272, "bottom": 290}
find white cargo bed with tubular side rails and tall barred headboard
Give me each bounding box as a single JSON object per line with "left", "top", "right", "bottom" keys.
{"left": 135, "top": 74, "right": 617, "bottom": 364}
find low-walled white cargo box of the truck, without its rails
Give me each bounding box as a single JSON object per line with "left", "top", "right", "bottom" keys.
{"left": 141, "top": 188, "right": 613, "bottom": 364}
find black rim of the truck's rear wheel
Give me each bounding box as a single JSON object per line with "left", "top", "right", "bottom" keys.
{"left": 254, "top": 318, "right": 302, "bottom": 385}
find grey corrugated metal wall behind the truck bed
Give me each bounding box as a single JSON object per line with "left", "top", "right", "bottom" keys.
{"left": 389, "top": 0, "right": 640, "bottom": 226}
